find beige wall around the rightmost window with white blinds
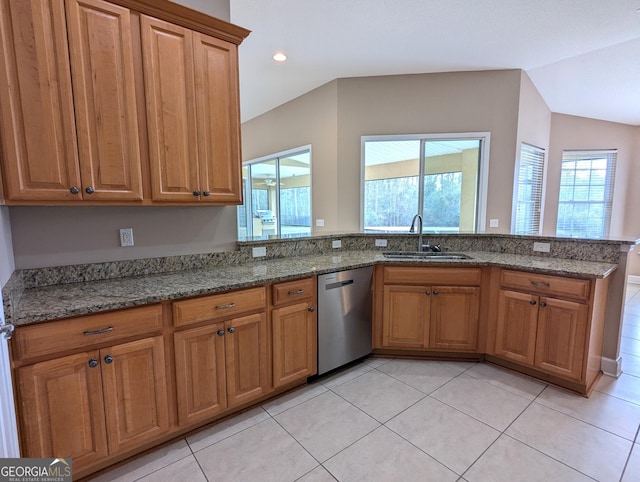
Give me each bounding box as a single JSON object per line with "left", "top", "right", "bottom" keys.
{"left": 543, "top": 113, "right": 640, "bottom": 238}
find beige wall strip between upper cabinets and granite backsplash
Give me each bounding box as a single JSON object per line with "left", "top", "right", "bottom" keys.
{"left": 10, "top": 206, "right": 237, "bottom": 269}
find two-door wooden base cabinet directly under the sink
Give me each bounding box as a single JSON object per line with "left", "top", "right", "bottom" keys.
{"left": 374, "top": 266, "right": 481, "bottom": 352}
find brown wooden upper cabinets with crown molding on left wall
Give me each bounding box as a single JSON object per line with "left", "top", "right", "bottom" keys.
{"left": 0, "top": 0, "right": 249, "bottom": 204}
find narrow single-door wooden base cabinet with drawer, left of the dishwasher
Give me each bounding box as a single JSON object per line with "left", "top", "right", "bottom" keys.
{"left": 271, "top": 277, "right": 318, "bottom": 388}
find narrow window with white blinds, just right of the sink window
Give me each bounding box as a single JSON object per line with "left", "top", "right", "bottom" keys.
{"left": 511, "top": 143, "right": 544, "bottom": 235}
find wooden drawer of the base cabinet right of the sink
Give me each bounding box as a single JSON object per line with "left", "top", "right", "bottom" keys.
{"left": 500, "top": 269, "right": 591, "bottom": 301}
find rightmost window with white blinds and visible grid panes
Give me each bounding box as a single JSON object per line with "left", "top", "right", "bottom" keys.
{"left": 556, "top": 150, "right": 617, "bottom": 238}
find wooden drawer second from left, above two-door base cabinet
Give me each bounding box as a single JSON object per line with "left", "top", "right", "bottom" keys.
{"left": 173, "top": 286, "right": 267, "bottom": 326}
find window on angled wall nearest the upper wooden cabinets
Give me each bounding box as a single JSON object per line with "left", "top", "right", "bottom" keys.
{"left": 238, "top": 147, "right": 311, "bottom": 239}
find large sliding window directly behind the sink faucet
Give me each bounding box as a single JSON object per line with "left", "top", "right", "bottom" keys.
{"left": 362, "top": 133, "right": 489, "bottom": 233}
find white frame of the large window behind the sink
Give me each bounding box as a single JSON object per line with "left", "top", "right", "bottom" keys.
{"left": 360, "top": 132, "right": 491, "bottom": 233}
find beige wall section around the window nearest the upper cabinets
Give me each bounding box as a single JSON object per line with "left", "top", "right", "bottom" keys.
{"left": 242, "top": 81, "right": 339, "bottom": 234}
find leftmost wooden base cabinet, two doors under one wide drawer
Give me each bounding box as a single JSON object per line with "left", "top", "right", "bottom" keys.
{"left": 15, "top": 305, "right": 169, "bottom": 473}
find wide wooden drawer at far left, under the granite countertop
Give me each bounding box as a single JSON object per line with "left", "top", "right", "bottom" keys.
{"left": 14, "top": 304, "right": 162, "bottom": 360}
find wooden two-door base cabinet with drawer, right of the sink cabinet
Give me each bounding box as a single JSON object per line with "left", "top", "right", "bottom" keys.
{"left": 490, "top": 270, "right": 608, "bottom": 392}
